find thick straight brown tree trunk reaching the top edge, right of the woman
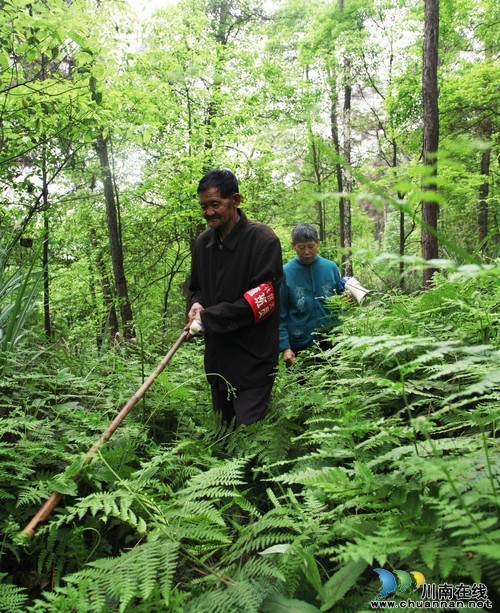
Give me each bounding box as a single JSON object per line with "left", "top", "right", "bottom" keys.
{"left": 422, "top": 0, "right": 439, "bottom": 287}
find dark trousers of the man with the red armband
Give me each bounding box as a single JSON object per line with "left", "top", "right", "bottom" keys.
{"left": 210, "top": 381, "right": 274, "bottom": 426}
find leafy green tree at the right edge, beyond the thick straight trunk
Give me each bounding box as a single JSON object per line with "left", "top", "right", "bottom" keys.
{"left": 439, "top": 0, "right": 500, "bottom": 253}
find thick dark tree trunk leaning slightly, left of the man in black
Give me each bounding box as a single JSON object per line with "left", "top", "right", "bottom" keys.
{"left": 96, "top": 136, "right": 134, "bottom": 338}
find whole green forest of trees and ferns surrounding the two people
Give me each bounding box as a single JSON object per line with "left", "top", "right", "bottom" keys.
{"left": 0, "top": 0, "right": 500, "bottom": 613}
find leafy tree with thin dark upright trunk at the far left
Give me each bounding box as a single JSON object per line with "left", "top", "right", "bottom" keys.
{"left": 0, "top": 0, "right": 125, "bottom": 346}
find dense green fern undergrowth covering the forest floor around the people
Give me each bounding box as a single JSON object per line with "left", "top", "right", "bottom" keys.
{"left": 0, "top": 260, "right": 500, "bottom": 613}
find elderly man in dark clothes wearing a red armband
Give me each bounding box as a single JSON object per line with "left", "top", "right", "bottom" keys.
{"left": 186, "top": 169, "right": 283, "bottom": 425}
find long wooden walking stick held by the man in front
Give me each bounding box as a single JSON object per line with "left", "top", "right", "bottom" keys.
{"left": 23, "top": 330, "right": 191, "bottom": 537}
